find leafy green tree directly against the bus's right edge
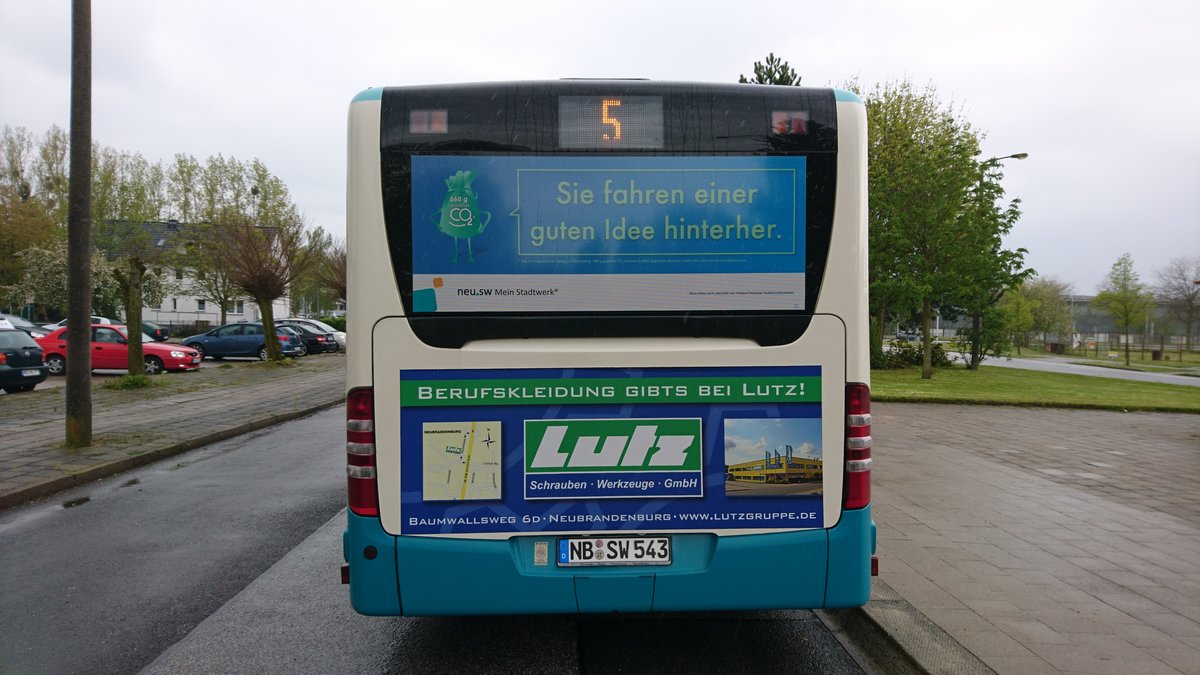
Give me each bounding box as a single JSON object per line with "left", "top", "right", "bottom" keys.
{"left": 851, "top": 82, "right": 980, "bottom": 380}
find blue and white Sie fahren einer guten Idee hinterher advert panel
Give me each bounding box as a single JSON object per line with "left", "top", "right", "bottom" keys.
{"left": 412, "top": 155, "right": 806, "bottom": 313}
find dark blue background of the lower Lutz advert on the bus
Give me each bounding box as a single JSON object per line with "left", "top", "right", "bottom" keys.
{"left": 401, "top": 366, "right": 823, "bottom": 534}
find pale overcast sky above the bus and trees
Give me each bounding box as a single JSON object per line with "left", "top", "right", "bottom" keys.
{"left": 0, "top": 0, "right": 1200, "bottom": 294}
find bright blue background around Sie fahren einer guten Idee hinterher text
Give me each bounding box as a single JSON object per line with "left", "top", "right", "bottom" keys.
{"left": 413, "top": 155, "right": 806, "bottom": 274}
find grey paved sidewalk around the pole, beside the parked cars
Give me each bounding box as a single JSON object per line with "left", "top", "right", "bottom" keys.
{"left": 0, "top": 352, "right": 346, "bottom": 508}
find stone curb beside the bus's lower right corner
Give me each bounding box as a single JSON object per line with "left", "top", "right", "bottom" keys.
{"left": 815, "top": 578, "right": 995, "bottom": 675}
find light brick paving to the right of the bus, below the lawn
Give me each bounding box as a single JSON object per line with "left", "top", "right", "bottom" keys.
{"left": 872, "top": 404, "right": 1200, "bottom": 674}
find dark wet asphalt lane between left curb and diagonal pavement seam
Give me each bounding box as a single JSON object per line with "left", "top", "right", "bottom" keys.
{"left": 0, "top": 410, "right": 346, "bottom": 673}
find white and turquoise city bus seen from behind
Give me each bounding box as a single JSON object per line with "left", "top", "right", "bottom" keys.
{"left": 342, "top": 79, "right": 876, "bottom": 616}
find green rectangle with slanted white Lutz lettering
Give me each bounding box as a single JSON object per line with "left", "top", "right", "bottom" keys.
{"left": 524, "top": 418, "right": 702, "bottom": 473}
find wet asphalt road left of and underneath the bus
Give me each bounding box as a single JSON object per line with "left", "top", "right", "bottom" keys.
{"left": 0, "top": 408, "right": 860, "bottom": 674}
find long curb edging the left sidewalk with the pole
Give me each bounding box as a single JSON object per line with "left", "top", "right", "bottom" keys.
{"left": 0, "top": 394, "right": 346, "bottom": 510}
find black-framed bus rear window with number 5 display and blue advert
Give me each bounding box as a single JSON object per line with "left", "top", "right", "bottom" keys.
{"left": 379, "top": 82, "right": 838, "bottom": 347}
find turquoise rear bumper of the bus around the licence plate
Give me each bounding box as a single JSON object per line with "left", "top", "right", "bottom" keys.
{"left": 342, "top": 506, "right": 875, "bottom": 616}
